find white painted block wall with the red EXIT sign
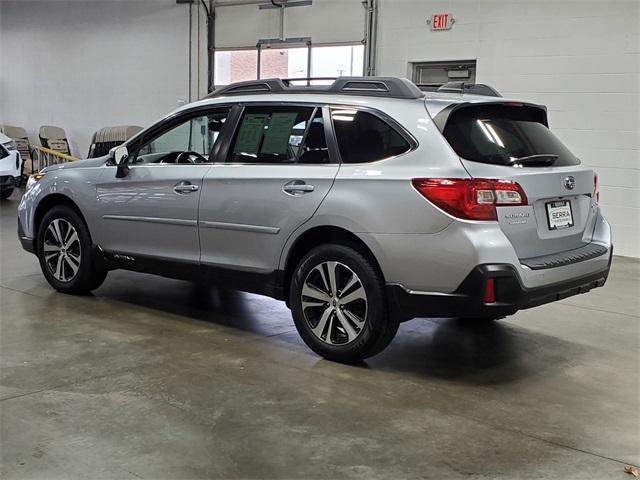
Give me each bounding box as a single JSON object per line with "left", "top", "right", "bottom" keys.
{"left": 378, "top": 0, "right": 640, "bottom": 257}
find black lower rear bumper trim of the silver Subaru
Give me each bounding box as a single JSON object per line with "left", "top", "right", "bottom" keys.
{"left": 387, "top": 249, "right": 613, "bottom": 320}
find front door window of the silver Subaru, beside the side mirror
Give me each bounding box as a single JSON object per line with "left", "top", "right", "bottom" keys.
{"left": 131, "top": 107, "right": 231, "bottom": 164}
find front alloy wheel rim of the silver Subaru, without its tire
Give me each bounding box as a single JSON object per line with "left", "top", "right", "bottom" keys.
{"left": 43, "top": 218, "right": 82, "bottom": 282}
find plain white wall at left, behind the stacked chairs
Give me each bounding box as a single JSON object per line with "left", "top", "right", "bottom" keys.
{"left": 0, "top": 0, "right": 191, "bottom": 156}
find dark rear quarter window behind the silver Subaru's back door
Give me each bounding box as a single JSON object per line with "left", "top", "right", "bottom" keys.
{"left": 331, "top": 108, "right": 411, "bottom": 163}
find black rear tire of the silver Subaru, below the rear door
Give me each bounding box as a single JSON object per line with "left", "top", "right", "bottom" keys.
{"left": 289, "top": 244, "right": 399, "bottom": 363}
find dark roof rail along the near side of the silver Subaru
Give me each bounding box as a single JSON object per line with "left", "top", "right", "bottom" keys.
{"left": 206, "top": 77, "right": 424, "bottom": 99}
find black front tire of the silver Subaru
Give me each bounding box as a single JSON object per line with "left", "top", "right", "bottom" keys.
{"left": 37, "top": 205, "right": 107, "bottom": 295}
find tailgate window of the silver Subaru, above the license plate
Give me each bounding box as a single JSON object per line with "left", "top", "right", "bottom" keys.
{"left": 444, "top": 105, "right": 580, "bottom": 166}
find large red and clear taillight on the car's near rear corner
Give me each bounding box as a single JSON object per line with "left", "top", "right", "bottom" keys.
{"left": 412, "top": 178, "right": 527, "bottom": 220}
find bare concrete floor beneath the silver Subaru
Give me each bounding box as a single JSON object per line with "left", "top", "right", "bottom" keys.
{"left": 0, "top": 189, "right": 640, "bottom": 479}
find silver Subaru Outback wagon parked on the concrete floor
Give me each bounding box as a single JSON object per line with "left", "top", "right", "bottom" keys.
{"left": 18, "top": 77, "right": 612, "bottom": 362}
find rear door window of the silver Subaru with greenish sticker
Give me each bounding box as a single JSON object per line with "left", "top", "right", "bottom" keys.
{"left": 227, "top": 105, "right": 331, "bottom": 164}
